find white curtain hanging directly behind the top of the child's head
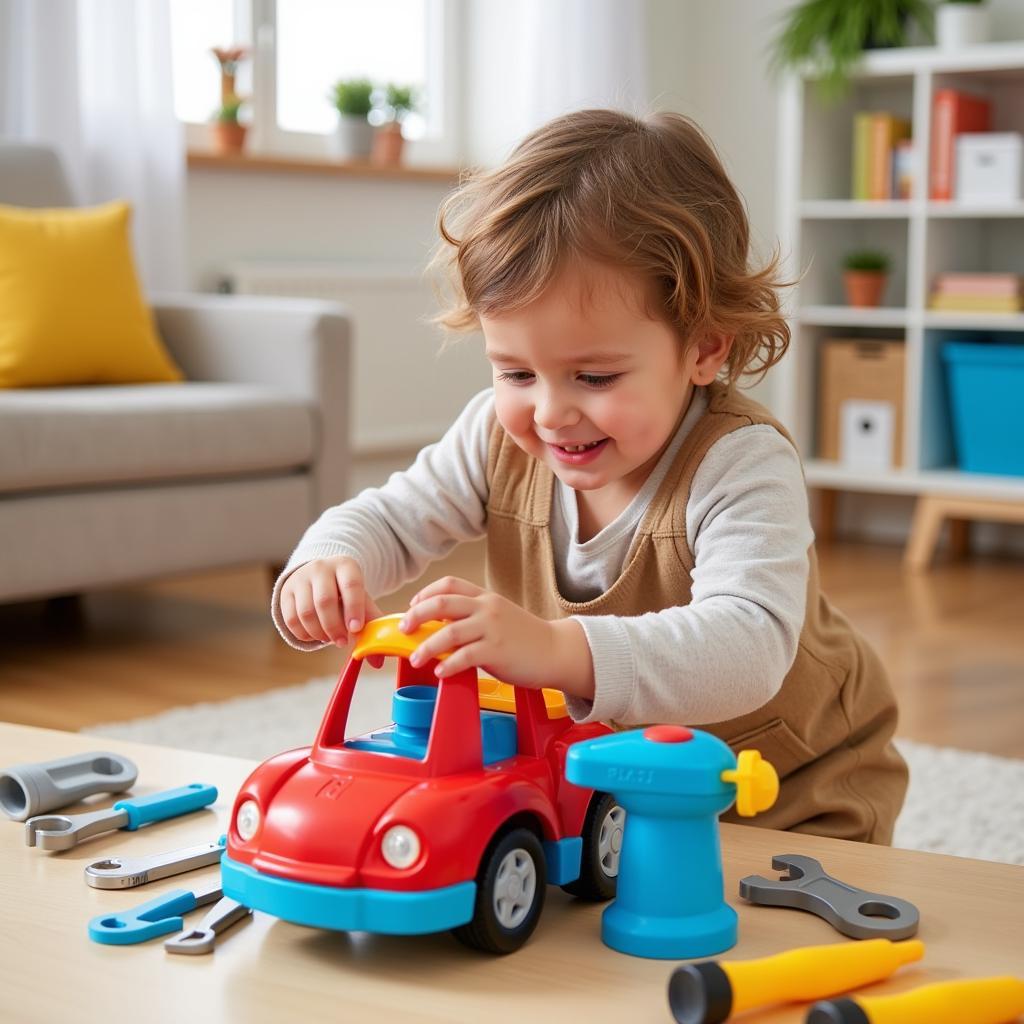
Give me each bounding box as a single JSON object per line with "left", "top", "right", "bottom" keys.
{"left": 465, "top": 0, "right": 649, "bottom": 165}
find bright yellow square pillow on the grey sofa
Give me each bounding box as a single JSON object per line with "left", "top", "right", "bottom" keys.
{"left": 0, "top": 203, "right": 182, "bottom": 387}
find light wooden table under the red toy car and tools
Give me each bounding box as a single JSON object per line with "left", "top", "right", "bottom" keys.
{"left": 0, "top": 723, "right": 1024, "bottom": 1024}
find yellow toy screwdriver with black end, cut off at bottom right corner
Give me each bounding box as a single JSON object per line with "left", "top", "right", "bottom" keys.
{"left": 807, "top": 977, "right": 1024, "bottom": 1024}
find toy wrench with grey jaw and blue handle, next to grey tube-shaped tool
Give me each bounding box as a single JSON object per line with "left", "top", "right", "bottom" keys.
{"left": 25, "top": 782, "right": 217, "bottom": 850}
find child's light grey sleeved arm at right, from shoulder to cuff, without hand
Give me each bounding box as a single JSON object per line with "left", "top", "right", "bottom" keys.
{"left": 568, "top": 425, "right": 813, "bottom": 725}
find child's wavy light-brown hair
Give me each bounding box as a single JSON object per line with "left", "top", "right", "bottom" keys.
{"left": 432, "top": 110, "right": 790, "bottom": 385}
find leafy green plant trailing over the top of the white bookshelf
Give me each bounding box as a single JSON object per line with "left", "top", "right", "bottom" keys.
{"left": 772, "top": 0, "right": 934, "bottom": 100}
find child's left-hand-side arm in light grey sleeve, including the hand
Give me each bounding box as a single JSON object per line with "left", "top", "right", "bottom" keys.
{"left": 271, "top": 388, "right": 495, "bottom": 650}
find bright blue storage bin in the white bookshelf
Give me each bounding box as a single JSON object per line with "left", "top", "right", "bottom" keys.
{"left": 942, "top": 341, "right": 1024, "bottom": 476}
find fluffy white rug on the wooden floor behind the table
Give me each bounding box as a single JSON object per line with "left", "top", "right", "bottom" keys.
{"left": 84, "top": 670, "right": 1024, "bottom": 864}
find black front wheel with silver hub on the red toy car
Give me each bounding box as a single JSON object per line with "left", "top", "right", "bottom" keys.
{"left": 452, "top": 828, "right": 548, "bottom": 954}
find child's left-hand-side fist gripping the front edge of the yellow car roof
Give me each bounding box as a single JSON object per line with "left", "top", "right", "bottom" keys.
{"left": 281, "top": 555, "right": 381, "bottom": 647}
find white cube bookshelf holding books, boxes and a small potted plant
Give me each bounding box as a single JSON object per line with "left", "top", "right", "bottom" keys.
{"left": 773, "top": 42, "right": 1024, "bottom": 501}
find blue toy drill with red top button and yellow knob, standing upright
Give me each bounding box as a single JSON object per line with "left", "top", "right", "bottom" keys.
{"left": 565, "top": 725, "right": 778, "bottom": 959}
